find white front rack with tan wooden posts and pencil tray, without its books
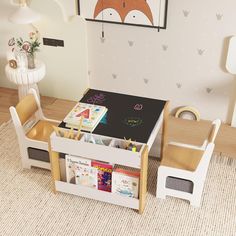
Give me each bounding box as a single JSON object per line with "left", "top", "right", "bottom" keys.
{"left": 50, "top": 132, "right": 148, "bottom": 214}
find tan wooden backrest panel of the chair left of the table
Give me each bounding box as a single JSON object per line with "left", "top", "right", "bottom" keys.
{"left": 16, "top": 94, "right": 38, "bottom": 125}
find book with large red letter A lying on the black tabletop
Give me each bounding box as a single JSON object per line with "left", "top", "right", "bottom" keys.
{"left": 63, "top": 102, "right": 107, "bottom": 132}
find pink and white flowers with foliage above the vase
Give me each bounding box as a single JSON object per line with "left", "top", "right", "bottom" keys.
{"left": 8, "top": 32, "right": 40, "bottom": 56}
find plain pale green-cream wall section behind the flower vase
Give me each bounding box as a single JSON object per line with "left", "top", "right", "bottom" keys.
{"left": 0, "top": 0, "right": 89, "bottom": 101}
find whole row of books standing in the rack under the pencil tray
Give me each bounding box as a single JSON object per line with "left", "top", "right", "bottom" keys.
{"left": 66, "top": 155, "right": 140, "bottom": 198}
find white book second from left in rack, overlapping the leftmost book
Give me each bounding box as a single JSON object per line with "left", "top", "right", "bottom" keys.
{"left": 75, "top": 164, "right": 98, "bottom": 189}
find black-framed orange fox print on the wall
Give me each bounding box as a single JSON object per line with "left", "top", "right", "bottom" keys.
{"left": 78, "top": 0, "right": 168, "bottom": 29}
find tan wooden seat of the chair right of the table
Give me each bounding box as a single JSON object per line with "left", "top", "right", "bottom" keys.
{"left": 161, "top": 144, "right": 203, "bottom": 171}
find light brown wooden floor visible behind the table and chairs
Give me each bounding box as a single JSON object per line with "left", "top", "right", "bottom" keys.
{"left": 0, "top": 88, "right": 236, "bottom": 158}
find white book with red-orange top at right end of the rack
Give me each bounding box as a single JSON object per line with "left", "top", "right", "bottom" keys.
{"left": 112, "top": 169, "right": 140, "bottom": 198}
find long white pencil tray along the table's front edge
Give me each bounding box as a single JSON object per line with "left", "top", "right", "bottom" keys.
{"left": 51, "top": 133, "right": 145, "bottom": 169}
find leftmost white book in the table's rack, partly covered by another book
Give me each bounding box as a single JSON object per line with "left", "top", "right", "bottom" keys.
{"left": 65, "top": 155, "right": 91, "bottom": 184}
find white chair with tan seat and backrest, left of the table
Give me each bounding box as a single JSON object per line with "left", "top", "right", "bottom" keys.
{"left": 9, "top": 89, "right": 59, "bottom": 169}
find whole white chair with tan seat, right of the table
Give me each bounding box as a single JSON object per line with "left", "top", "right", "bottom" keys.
{"left": 156, "top": 119, "right": 221, "bottom": 207}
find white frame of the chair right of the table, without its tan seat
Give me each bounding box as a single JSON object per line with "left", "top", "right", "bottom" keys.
{"left": 156, "top": 119, "right": 221, "bottom": 207}
